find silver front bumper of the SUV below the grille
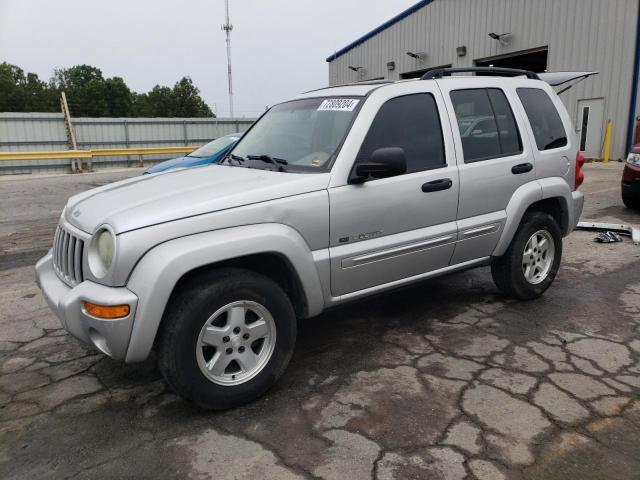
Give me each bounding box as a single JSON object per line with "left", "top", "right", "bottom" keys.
{"left": 36, "top": 252, "right": 138, "bottom": 360}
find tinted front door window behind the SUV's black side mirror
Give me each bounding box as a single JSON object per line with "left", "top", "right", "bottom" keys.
{"left": 356, "top": 93, "right": 446, "bottom": 173}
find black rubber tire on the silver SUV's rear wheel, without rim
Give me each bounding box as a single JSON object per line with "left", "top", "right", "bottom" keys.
{"left": 491, "top": 211, "right": 562, "bottom": 300}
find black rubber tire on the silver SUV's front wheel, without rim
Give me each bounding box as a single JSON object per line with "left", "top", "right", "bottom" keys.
{"left": 157, "top": 268, "right": 296, "bottom": 410}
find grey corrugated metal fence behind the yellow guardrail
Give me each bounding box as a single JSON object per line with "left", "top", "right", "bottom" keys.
{"left": 0, "top": 112, "right": 254, "bottom": 174}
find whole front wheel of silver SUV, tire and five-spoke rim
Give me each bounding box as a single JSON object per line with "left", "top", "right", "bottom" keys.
{"left": 158, "top": 269, "right": 296, "bottom": 410}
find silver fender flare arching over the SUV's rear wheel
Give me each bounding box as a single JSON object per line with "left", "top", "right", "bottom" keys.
{"left": 492, "top": 177, "right": 574, "bottom": 257}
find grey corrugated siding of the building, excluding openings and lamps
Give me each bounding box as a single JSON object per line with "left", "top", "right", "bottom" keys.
{"left": 329, "top": 0, "right": 639, "bottom": 158}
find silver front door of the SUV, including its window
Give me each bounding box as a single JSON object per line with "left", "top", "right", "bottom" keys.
{"left": 329, "top": 86, "right": 459, "bottom": 297}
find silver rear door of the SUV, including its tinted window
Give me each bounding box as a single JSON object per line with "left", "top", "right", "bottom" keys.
{"left": 439, "top": 82, "right": 536, "bottom": 264}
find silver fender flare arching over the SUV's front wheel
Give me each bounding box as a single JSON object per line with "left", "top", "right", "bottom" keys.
{"left": 126, "top": 223, "right": 324, "bottom": 363}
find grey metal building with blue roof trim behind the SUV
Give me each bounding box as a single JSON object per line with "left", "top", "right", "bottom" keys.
{"left": 327, "top": 0, "right": 640, "bottom": 158}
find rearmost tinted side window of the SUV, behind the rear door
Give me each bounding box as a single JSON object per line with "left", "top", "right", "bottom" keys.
{"left": 517, "top": 88, "right": 567, "bottom": 150}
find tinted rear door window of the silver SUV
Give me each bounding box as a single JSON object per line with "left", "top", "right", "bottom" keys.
{"left": 451, "top": 88, "right": 522, "bottom": 163}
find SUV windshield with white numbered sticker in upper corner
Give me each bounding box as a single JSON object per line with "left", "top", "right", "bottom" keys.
{"left": 228, "top": 98, "right": 361, "bottom": 172}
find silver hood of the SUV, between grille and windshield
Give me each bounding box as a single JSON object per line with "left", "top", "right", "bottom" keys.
{"left": 65, "top": 165, "right": 330, "bottom": 234}
